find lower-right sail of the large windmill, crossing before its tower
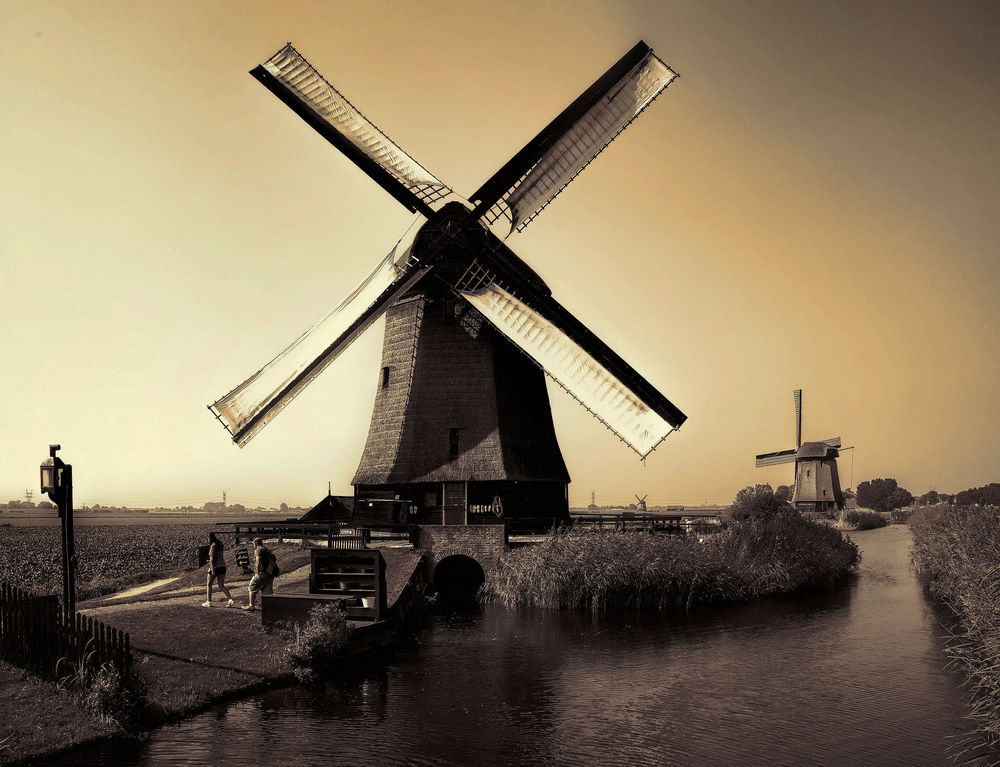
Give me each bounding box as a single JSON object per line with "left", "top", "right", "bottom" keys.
{"left": 456, "top": 280, "right": 686, "bottom": 457}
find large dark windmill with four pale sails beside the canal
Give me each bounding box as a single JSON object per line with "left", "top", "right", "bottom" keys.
{"left": 209, "top": 42, "right": 686, "bottom": 523}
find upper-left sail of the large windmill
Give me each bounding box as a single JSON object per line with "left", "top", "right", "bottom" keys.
{"left": 250, "top": 43, "right": 451, "bottom": 215}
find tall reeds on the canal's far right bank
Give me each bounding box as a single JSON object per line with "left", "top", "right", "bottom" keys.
{"left": 910, "top": 506, "right": 1000, "bottom": 764}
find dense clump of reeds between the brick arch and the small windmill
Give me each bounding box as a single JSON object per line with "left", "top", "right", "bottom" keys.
{"left": 489, "top": 513, "right": 861, "bottom": 610}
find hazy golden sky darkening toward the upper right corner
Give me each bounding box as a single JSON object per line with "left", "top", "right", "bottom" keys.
{"left": 0, "top": 0, "right": 1000, "bottom": 506}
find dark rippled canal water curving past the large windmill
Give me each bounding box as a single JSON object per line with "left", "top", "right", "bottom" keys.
{"left": 45, "top": 526, "right": 965, "bottom": 767}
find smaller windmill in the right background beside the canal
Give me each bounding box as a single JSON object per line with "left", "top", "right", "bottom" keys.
{"left": 757, "top": 389, "right": 851, "bottom": 511}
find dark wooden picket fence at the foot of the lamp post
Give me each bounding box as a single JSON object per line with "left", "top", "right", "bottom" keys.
{"left": 0, "top": 582, "right": 132, "bottom": 686}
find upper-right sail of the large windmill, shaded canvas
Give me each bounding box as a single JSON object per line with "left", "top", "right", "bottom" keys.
{"left": 473, "top": 43, "right": 677, "bottom": 231}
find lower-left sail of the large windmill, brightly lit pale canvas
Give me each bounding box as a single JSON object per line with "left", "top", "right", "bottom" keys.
{"left": 209, "top": 219, "right": 430, "bottom": 447}
